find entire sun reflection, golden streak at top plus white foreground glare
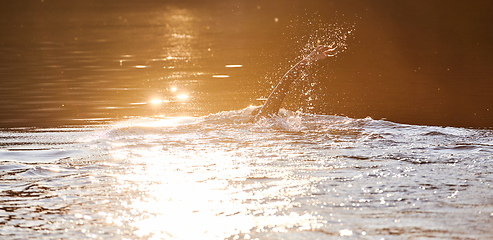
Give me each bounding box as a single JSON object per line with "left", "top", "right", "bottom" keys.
{"left": 96, "top": 5, "right": 324, "bottom": 239}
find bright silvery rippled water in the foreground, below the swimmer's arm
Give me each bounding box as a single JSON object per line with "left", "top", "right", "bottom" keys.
{"left": 0, "top": 107, "right": 493, "bottom": 239}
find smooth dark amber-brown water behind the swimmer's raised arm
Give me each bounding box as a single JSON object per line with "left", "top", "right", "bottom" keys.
{"left": 0, "top": 0, "right": 493, "bottom": 128}
